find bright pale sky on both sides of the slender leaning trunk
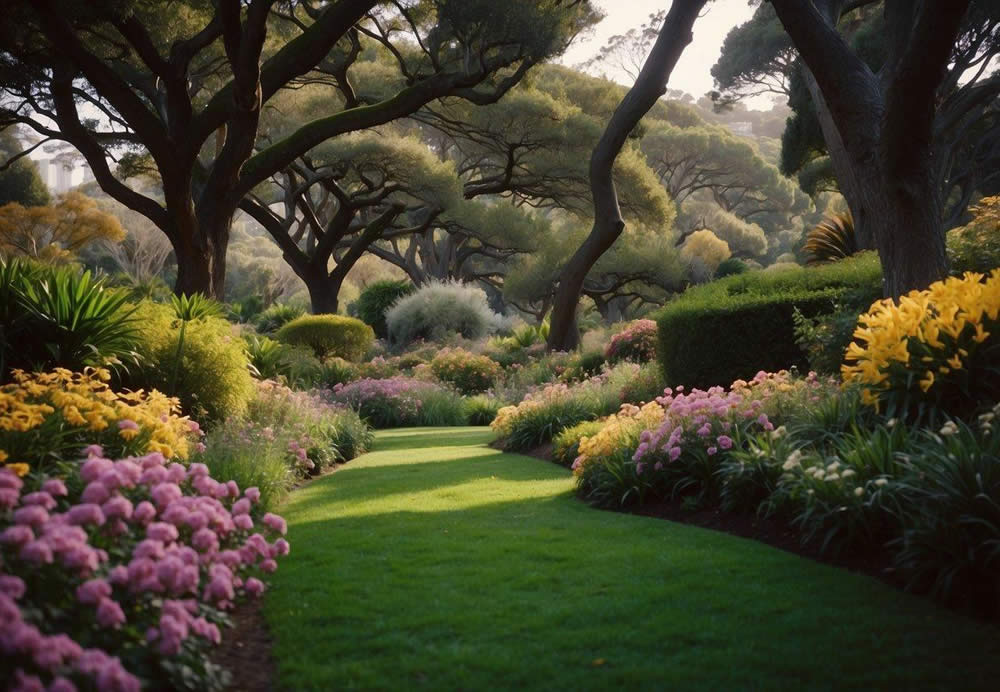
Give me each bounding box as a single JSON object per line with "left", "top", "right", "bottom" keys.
{"left": 562, "top": 0, "right": 756, "bottom": 104}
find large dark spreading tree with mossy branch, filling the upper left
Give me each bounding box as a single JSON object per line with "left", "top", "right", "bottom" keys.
{"left": 0, "top": 0, "right": 595, "bottom": 297}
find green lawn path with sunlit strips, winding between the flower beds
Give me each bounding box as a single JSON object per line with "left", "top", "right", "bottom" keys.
{"left": 265, "top": 428, "right": 1000, "bottom": 690}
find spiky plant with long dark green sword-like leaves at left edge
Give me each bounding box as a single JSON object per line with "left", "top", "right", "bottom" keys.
{"left": 0, "top": 258, "right": 138, "bottom": 379}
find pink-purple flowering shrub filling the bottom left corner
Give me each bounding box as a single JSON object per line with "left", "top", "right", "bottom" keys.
{"left": 0, "top": 446, "right": 289, "bottom": 691}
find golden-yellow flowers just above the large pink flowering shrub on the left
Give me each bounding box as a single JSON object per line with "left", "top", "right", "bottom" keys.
{"left": 0, "top": 368, "right": 199, "bottom": 475}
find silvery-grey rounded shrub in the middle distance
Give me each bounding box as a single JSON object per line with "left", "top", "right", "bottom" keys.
{"left": 385, "top": 281, "right": 504, "bottom": 344}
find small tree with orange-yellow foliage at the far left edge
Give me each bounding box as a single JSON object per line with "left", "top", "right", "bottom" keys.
{"left": 0, "top": 192, "right": 125, "bottom": 263}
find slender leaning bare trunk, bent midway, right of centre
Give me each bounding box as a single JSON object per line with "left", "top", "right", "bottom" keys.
{"left": 547, "top": 0, "right": 707, "bottom": 351}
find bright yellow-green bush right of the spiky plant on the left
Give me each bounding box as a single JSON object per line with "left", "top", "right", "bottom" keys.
{"left": 129, "top": 301, "right": 254, "bottom": 421}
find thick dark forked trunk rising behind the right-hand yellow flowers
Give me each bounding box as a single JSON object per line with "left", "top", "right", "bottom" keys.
{"left": 772, "top": 0, "right": 980, "bottom": 296}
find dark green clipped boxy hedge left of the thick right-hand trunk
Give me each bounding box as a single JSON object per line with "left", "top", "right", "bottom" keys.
{"left": 656, "top": 253, "right": 882, "bottom": 388}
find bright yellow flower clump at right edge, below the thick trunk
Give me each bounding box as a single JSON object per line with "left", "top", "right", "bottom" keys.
{"left": 842, "top": 269, "right": 1000, "bottom": 416}
